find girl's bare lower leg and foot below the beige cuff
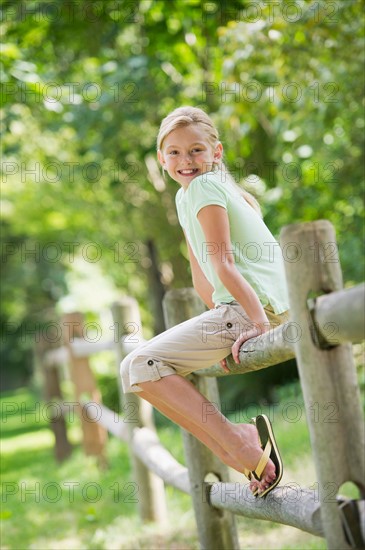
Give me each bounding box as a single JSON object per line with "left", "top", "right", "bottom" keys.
{"left": 139, "top": 374, "right": 276, "bottom": 489}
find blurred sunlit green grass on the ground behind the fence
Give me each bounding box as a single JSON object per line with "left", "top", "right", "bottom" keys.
{"left": 1, "top": 388, "right": 350, "bottom": 550}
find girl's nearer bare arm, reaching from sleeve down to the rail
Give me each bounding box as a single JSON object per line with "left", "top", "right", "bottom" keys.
{"left": 198, "top": 204, "right": 270, "bottom": 330}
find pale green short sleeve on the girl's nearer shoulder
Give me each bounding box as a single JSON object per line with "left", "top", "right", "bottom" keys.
{"left": 189, "top": 174, "right": 227, "bottom": 217}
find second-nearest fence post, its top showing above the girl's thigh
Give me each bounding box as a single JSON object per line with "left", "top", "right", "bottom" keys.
{"left": 163, "top": 288, "right": 239, "bottom": 550}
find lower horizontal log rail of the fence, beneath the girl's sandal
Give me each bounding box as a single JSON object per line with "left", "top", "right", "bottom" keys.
{"left": 76, "top": 401, "right": 365, "bottom": 537}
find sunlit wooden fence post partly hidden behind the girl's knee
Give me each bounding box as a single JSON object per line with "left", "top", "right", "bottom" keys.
{"left": 111, "top": 297, "right": 167, "bottom": 523}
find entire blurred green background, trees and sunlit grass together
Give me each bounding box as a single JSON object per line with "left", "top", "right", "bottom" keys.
{"left": 0, "top": 0, "right": 364, "bottom": 549}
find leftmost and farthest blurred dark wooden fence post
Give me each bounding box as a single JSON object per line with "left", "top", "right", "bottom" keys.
{"left": 36, "top": 332, "right": 72, "bottom": 462}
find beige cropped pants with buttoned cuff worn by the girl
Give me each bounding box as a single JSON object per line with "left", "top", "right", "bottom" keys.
{"left": 120, "top": 302, "right": 289, "bottom": 393}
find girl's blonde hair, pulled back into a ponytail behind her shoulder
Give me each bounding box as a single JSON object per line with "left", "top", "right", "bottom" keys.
{"left": 157, "top": 106, "right": 262, "bottom": 217}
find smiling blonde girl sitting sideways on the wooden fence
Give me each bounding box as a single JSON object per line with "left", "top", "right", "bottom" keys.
{"left": 121, "top": 107, "right": 288, "bottom": 496}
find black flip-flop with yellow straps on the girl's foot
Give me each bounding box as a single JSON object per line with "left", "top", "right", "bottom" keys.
{"left": 244, "top": 414, "right": 283, "bottom": 497}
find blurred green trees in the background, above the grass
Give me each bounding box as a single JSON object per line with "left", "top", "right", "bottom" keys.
{"left": 1, "top": 0, "right": 364, "bottom": 401}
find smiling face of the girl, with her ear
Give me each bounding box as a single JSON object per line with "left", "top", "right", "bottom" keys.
{"left": 158, "top": 124, "right": 223, "bottom": 189}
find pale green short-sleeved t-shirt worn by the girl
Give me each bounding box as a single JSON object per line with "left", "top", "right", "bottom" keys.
{"left": 176, "top": 171, "right": 289, "bottom": 313}
